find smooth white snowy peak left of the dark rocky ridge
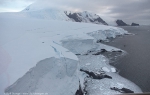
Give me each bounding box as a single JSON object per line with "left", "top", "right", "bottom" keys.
{"left": 22, "top": 4, "right": 71, "bottom": 21}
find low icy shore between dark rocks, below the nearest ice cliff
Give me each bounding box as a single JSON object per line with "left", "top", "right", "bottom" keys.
{"left": 78, "top": 54, "right": 142, "bottom": 95}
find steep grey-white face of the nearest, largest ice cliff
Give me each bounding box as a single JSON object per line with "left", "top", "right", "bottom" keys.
{"left": 6, "top": 57, "right": 79, "bottom": 95}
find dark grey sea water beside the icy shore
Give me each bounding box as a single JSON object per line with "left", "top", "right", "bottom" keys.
{"left": 105, "top": 26, "right": 150, "bottom": 92}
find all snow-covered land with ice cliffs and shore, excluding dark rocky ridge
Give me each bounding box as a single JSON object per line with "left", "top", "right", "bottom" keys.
{"left": 0, "top": 2, "right": 142, "bottom": 95}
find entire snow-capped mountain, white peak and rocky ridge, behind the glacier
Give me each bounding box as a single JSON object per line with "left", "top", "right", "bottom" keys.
{"left": 22, "top": 4, "right": 108, "bottom": 25}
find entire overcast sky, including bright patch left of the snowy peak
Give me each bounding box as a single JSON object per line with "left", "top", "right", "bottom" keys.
{"left": 0, "top": 0, "right": 150, "bottom": 24}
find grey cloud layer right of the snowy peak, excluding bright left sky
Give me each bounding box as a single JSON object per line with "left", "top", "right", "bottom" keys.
{"left": 35, "top": 0, "right": 150, "bottom": 23}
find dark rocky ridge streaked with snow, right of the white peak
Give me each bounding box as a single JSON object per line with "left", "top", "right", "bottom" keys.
{"left": 65, "top": 11, "right": 108, "bottom": 25}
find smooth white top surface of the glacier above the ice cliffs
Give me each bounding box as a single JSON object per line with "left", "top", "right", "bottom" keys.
{"left": 0, "top": 12, "right": 131, "bottom": 93}
